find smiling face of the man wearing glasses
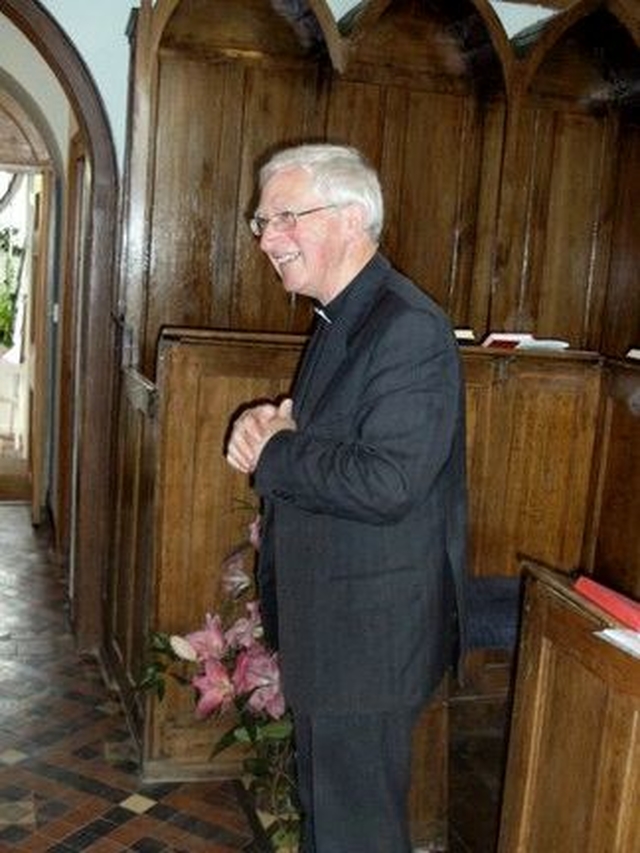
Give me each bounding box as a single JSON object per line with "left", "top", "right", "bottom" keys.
{"left": 258, "top": 167, "right": 352, "bottom": 305}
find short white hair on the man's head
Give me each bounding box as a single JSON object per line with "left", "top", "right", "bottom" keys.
{"left": 259, "top": 143, "right": 384, "bottom": 238}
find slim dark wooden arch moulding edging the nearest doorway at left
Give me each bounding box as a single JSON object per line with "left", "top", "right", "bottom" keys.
{"left": 0, "top": 0, "right": 118, "bottom": 651}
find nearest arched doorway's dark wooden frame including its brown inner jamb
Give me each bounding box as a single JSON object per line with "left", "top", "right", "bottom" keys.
{"left": 0, "top": 0, "right": 118, "bottom": 651}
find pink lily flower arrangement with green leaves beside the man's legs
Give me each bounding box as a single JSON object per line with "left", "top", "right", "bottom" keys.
{"left": 139, "top": 522, "right": 300, "bottom": 853}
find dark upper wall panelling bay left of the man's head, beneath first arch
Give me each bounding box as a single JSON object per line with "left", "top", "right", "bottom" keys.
{"left": 144, "top": 57, "right": 328, "bottom": 375}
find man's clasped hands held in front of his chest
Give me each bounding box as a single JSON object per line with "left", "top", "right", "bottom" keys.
{"left": 226, "top": 397, "right": 296, "bottom": 474}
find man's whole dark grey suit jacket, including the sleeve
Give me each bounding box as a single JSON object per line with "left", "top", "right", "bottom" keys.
{"left": 254, "top": 255, "right": 466, "bottom": 714}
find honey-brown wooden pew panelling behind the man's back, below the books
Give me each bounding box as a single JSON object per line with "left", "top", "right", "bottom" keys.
{"left": 464, "top": 350, "right": 601, "bottom": 575}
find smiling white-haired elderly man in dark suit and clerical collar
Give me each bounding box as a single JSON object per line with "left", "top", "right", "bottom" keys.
{"left": 227, "top": 144, "right": 466, "bottom": 853}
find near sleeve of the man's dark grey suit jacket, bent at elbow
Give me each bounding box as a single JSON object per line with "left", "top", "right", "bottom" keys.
{"left": 254, "top": 306, "right": 461, "bottom": 524}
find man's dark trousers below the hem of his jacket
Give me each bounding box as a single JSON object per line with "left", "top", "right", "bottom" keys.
{"left": 295, "top": 709, "right": 418, "bottom": 853}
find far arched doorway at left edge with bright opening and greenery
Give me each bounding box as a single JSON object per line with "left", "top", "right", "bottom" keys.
{"left": 0, "top": 75, "right": 57, "bottom": 506}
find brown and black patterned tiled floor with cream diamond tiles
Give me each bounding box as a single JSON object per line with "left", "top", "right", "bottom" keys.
{"left": 0, "top": 502, "right": 501, "bottom": 853}
